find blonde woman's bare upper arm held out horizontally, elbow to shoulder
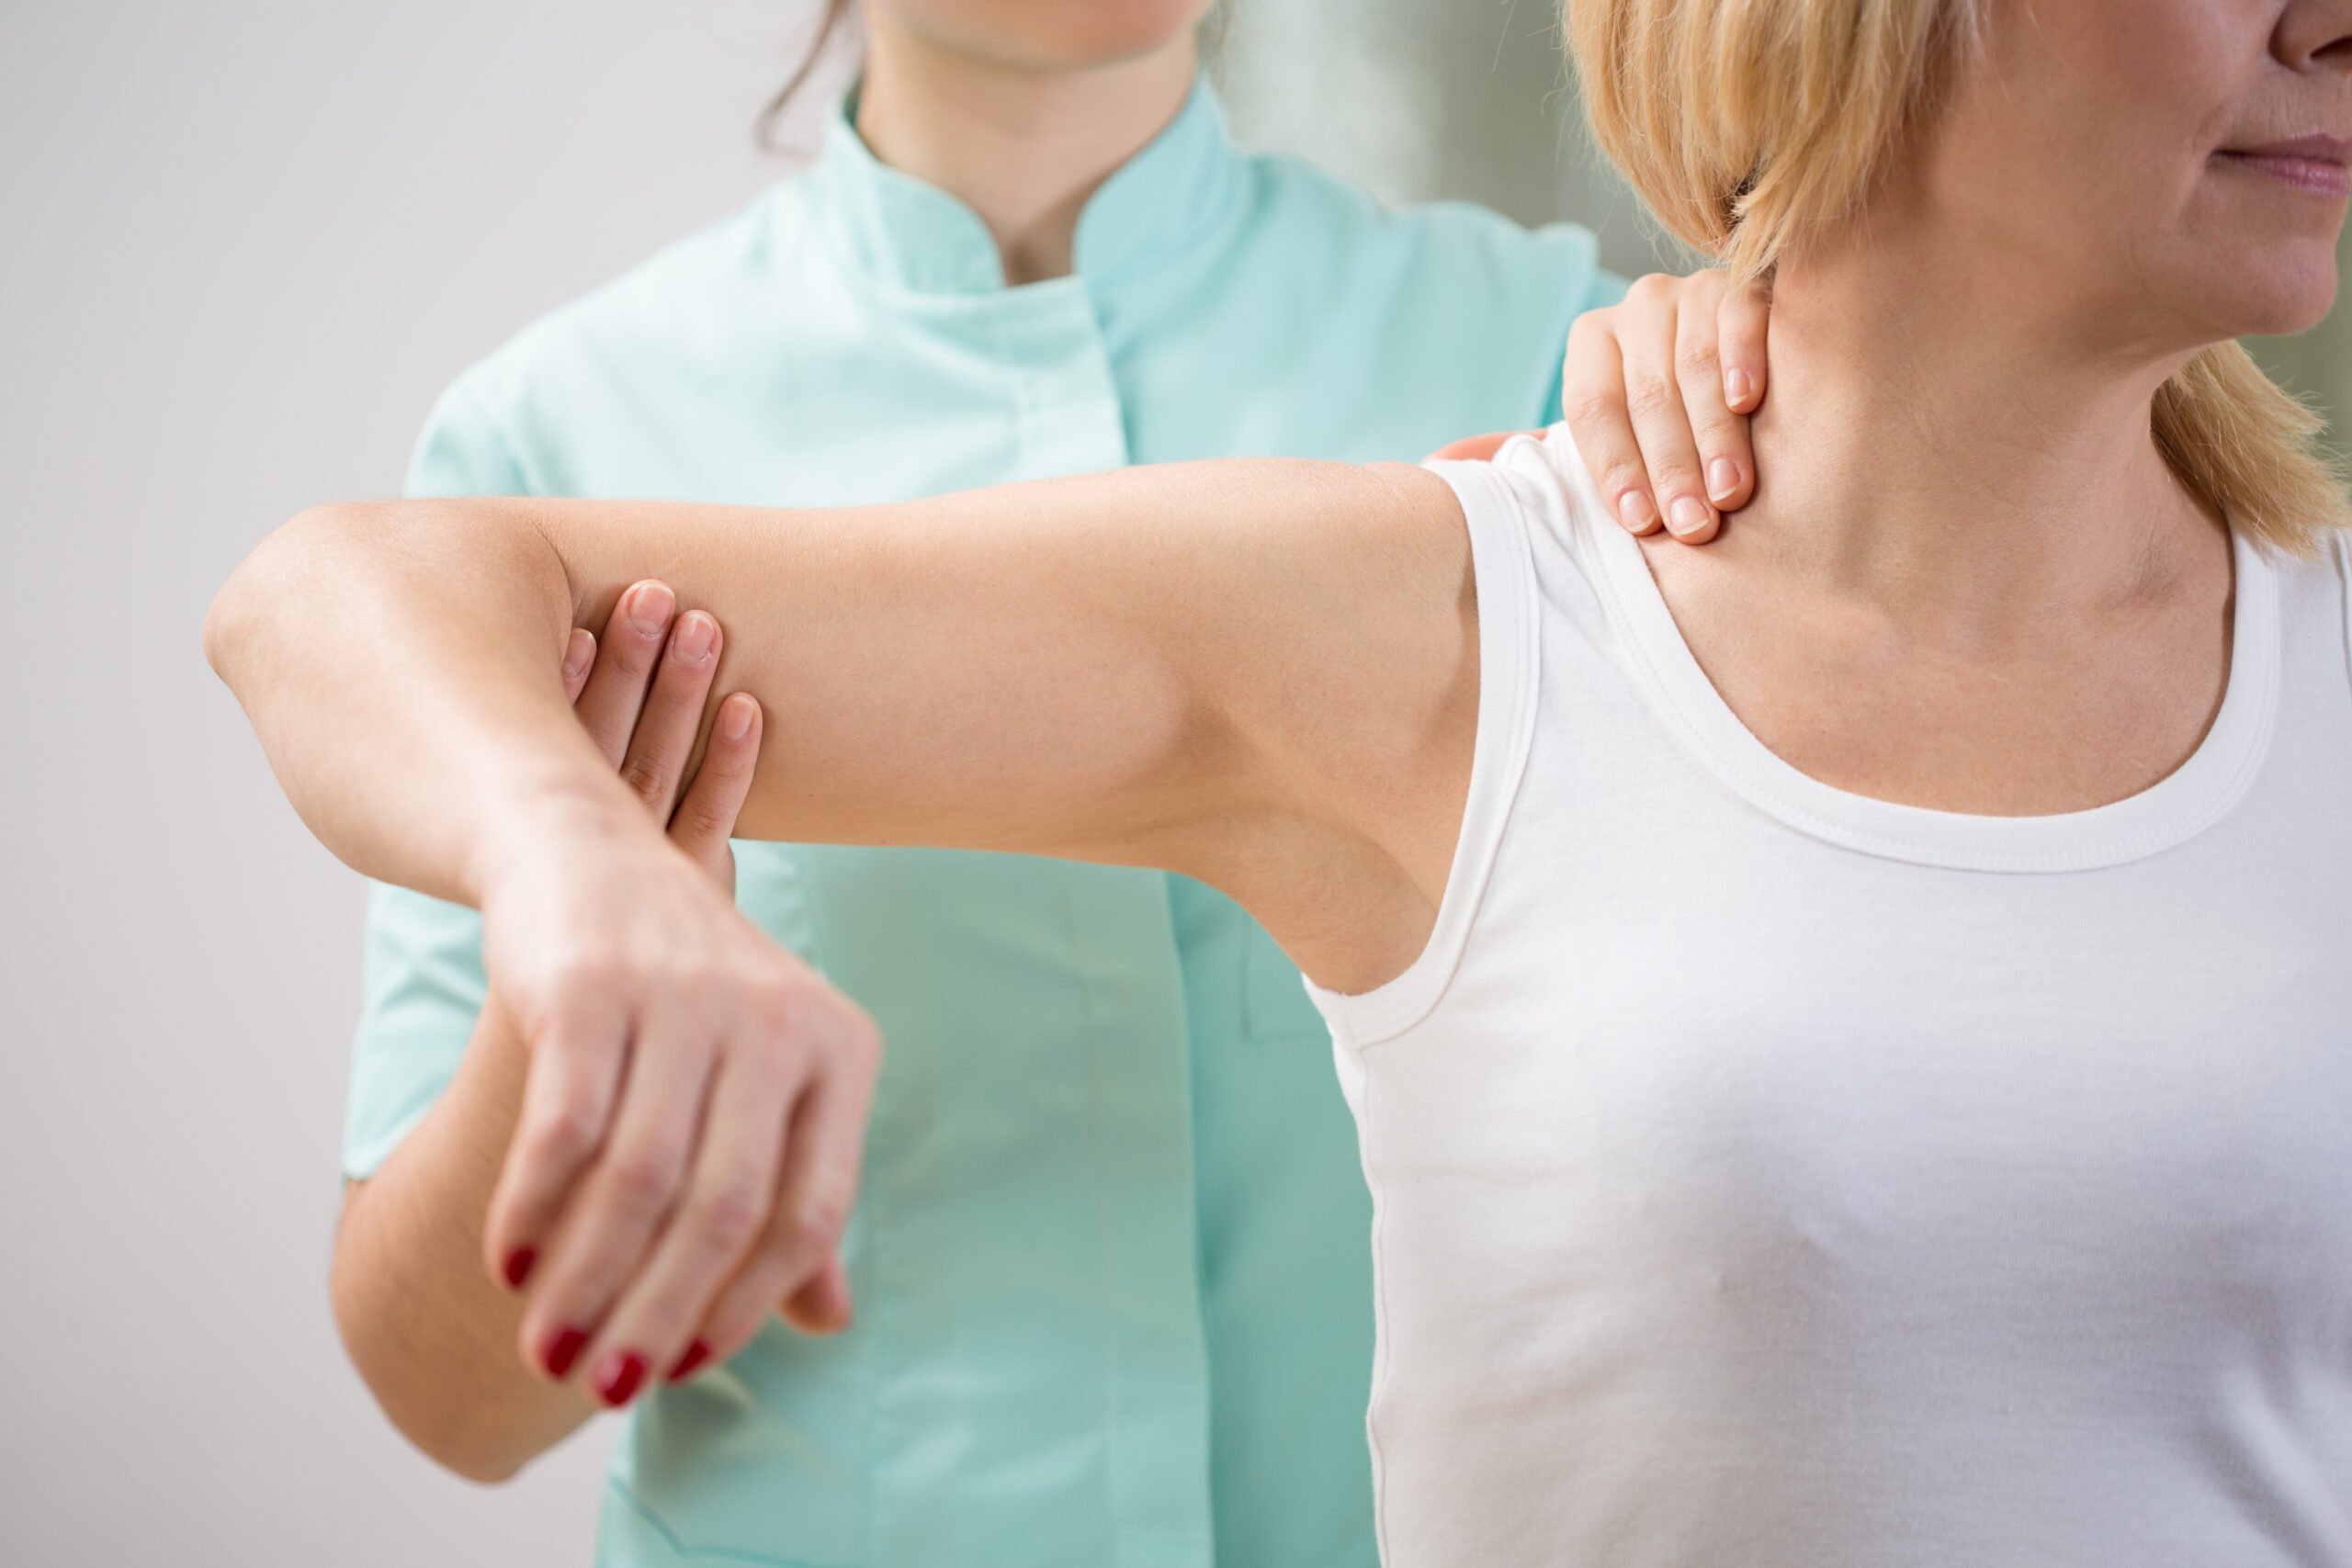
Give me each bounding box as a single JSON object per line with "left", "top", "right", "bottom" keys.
{"left": 534, "top": 461, "right": 1477, "bottom": 968}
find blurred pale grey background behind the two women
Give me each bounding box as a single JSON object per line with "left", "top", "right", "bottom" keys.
{"left": 0, "top": 0, "right": 2352, "bottom": 1568}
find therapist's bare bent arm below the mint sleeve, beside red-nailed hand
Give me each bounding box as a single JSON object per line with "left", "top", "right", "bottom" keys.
{"left": 334, "top": 1004, "right": 595, "bottom": 1481}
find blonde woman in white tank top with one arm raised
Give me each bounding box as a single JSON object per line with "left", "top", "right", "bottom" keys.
{"left": 207, "top": 0, "right": 2352, "bottom": 1568}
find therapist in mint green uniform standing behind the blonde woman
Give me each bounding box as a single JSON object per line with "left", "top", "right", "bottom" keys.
{"left": 334, "top": 0, "right": 1764, "bottom": 1568}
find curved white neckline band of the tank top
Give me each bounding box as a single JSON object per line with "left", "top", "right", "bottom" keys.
{"left": 1553, "top": 446, "right": 2279, "bottom": 872}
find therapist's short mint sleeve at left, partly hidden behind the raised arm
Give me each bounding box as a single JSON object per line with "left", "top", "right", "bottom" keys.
{"left": 344, "top": 381, "right": 526, "bottom": 1180}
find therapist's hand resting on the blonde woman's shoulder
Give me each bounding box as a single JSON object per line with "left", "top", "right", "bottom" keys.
{"left": 1432, "top": 268, "right": 1771, "bottom": 546}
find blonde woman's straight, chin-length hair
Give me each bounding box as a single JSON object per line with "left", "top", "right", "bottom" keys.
{"left": 1562, "top": 0, "right": 2347, "bottom": 555}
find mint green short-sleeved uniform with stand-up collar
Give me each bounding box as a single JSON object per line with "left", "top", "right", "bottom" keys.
{"left": 345, "top": 89, "right": 1623, "bottom": 1568}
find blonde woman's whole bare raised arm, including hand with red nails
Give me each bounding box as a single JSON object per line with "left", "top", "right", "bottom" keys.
{"left": 207, "top": 463, "right": 1477, "bottom": 1410}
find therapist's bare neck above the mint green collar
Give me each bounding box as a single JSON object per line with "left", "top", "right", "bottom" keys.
{"left": 858, "top": 17, "right": 1194, "bottom": 285}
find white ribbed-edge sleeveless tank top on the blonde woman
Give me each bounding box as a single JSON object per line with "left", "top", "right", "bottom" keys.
{"left": 1310, "top": 428, "right": 2352, "bottom": 1568}
